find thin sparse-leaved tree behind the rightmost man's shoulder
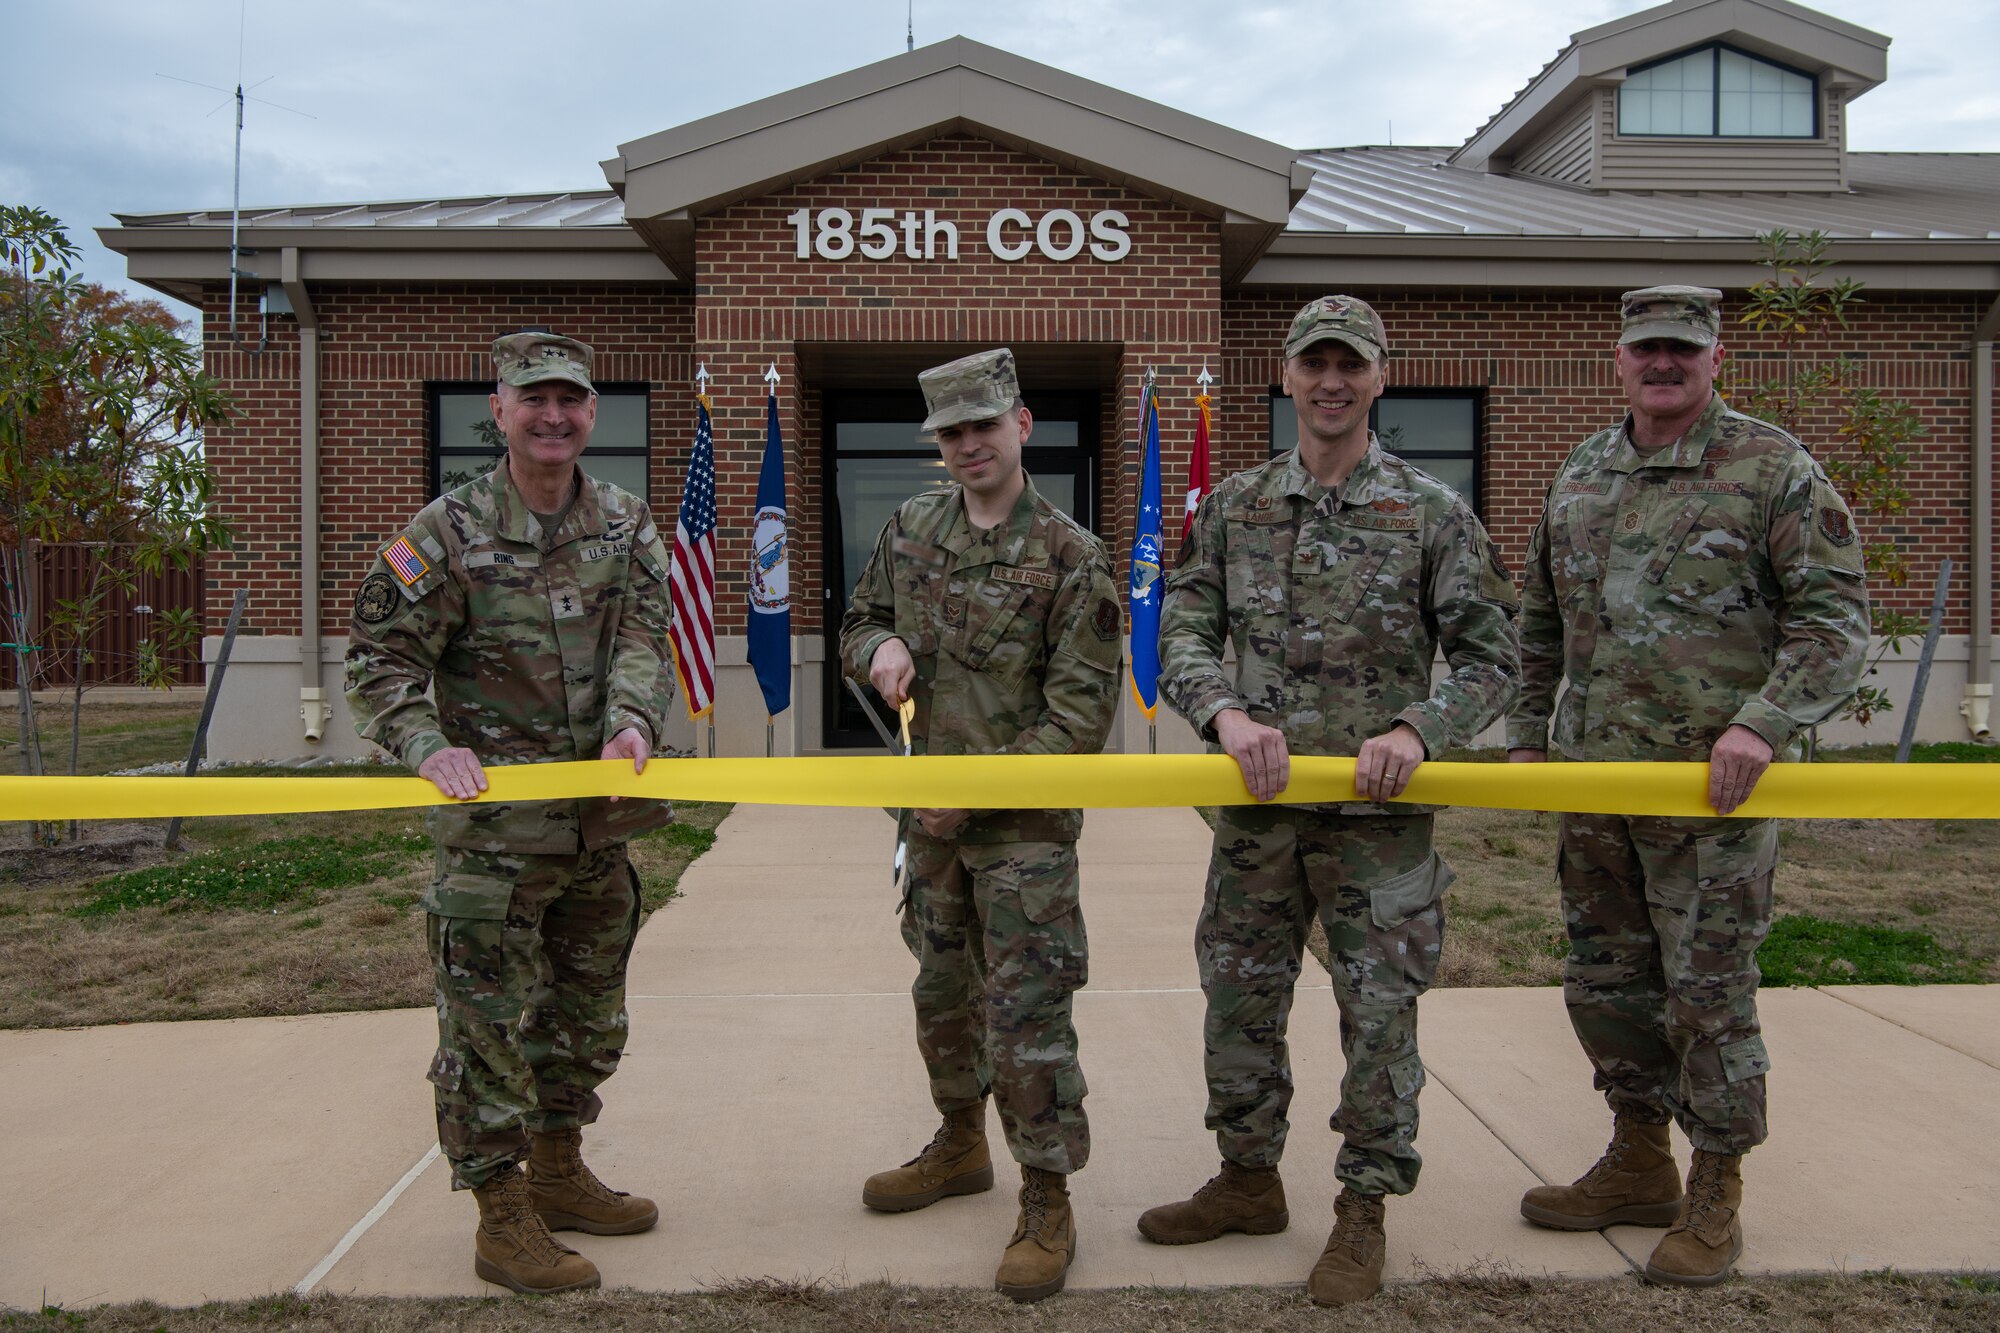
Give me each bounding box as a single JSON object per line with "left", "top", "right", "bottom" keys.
{"left": 1734, "top": 228, "right": 1928, "bottom": 727}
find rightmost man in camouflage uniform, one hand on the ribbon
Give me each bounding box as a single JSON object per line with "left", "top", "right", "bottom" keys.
{"left": 1508, "top": 286, "right": 1868, "bottom": 1285}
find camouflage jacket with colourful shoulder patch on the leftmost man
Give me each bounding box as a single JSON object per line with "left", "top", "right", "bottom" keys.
{"left": 348, "top": 458, "right": 674, "bottom": 853}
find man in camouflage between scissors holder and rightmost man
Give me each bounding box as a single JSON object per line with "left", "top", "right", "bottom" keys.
{"left": 1138, "top": 296, "right": 1518, "bottom": 1305}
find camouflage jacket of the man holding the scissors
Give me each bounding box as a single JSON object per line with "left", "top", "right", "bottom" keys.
{"left": 840, "top": 480, "right": 1124, "bottom": 843}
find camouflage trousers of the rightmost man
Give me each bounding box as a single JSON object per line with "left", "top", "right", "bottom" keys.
{"left": 1556, "top": 815, "right": 1778, "bottom": 1153}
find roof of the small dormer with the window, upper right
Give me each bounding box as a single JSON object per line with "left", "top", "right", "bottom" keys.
{"left": 1450, "top": 0, "right": 1888, "bottom": 168}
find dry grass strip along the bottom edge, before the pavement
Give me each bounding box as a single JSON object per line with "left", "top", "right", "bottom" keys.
{"left": 15, "top": 1267, "right": 2000, "bottom": 1333}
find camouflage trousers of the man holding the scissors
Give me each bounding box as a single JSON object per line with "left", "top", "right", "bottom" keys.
{"left": 902, "top": 823, "right": 1090, "bottom": 1173}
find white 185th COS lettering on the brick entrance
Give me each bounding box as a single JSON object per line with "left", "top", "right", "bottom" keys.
{"left": 784, "top": 208, "right": 1132, "bottom": 264}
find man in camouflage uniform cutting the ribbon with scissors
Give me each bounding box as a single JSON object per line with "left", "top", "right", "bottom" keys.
{"left": 840, "top": 348, "right": 1122, "bottom": 1301}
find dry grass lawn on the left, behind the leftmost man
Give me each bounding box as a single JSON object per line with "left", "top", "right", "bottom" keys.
{"left": 0, "top": 803, "right": 730, "bottom": 1027}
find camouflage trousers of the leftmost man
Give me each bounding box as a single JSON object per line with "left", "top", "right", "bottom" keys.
{"left": 430, "top": 843, "right": 638, "bottom": 1189}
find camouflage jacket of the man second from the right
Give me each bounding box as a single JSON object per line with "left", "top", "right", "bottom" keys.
{"left": 1160, "top": 436, "right": 1518, "bottom": 815}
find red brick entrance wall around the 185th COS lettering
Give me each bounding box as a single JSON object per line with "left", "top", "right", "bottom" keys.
{"left": 694, "top": 136, "right": 1222, "bottom": 632}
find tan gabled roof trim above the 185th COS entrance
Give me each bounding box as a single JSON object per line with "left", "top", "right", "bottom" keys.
{"left": 604, "top": 36, "right": 1304, "bottom": 282}
